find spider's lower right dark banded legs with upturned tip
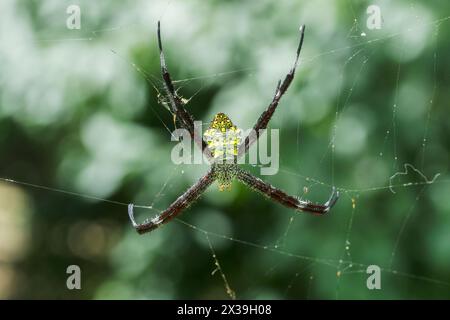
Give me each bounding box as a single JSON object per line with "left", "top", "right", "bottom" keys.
{"left": 237, "top": 169, "right": 339, "bottom": 215}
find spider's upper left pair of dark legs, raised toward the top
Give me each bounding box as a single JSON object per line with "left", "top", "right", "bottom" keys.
{"left": 157, "top": 21, "right": 212, "bottom": 159}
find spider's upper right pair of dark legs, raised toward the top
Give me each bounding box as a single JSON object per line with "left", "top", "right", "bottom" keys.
{"left": 238, "top": 25, "right": 305, "bottom": 157}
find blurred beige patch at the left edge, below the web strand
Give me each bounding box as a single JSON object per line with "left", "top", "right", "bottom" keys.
{"left": 0, "top": 182, "right": 31, "bottom": 299}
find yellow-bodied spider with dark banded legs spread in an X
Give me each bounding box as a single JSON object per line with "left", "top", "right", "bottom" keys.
{"left": 128, "top": 21, "right": 339, "bottom": 234}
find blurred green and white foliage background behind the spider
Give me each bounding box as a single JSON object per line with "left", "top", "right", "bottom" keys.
{"left": 0, "top": 0, "right": 450, "bottom": 299}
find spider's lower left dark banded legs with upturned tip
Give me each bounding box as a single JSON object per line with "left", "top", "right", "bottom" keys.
{"left": 128, "top": 170, "right": 215, "bottom": 234}
